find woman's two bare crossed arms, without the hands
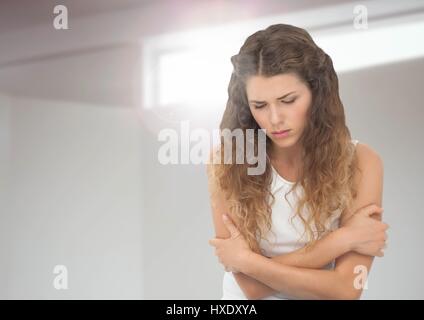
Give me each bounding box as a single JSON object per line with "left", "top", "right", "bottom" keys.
{"left": 207, "top": 144, "right": 383, "bottom": 299}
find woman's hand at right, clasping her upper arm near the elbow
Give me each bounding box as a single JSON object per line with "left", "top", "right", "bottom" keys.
{"left": 343, "top": 204, "right": 389, "bottom": 257}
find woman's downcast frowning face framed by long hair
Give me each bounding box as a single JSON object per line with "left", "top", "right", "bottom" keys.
{"left": 246, "top": 73, "right": 312, "bottom": 148}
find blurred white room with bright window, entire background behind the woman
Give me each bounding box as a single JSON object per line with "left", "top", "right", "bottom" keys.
{"left": 0, "top": 0, "right": 424, "bottom": 300}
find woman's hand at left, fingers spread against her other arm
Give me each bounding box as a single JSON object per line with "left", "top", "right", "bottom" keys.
{"left": 209, "top": 214, "right": 252, "bottom": 272}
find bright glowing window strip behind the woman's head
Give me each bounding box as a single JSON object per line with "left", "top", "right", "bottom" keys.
{"left": 142, "top": 0, "right": 424, "bottom": 109}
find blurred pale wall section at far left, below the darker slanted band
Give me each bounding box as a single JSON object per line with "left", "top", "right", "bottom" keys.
{"left": 0, "top": 94, "right": 143, "bottom": 299}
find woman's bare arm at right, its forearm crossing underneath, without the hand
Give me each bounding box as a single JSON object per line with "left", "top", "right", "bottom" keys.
{"left": 234, "top": 144, "right": 383, "bottom": 299}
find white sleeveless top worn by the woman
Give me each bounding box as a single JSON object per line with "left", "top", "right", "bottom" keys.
{"left": 221, "top": 139, "right": 358, "bottom": 300}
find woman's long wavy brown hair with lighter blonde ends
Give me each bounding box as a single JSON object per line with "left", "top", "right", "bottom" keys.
{"left": 212, "top": 24, "right": 359, "bottom": 253}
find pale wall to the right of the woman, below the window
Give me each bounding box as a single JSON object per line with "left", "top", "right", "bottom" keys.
{"left": 340, "top": 58, "right": 424, "bottom": 299}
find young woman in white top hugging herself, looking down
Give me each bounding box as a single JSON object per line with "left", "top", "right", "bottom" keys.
{"left": 207, "top": 24, "right": 388, "bottom": 299}
